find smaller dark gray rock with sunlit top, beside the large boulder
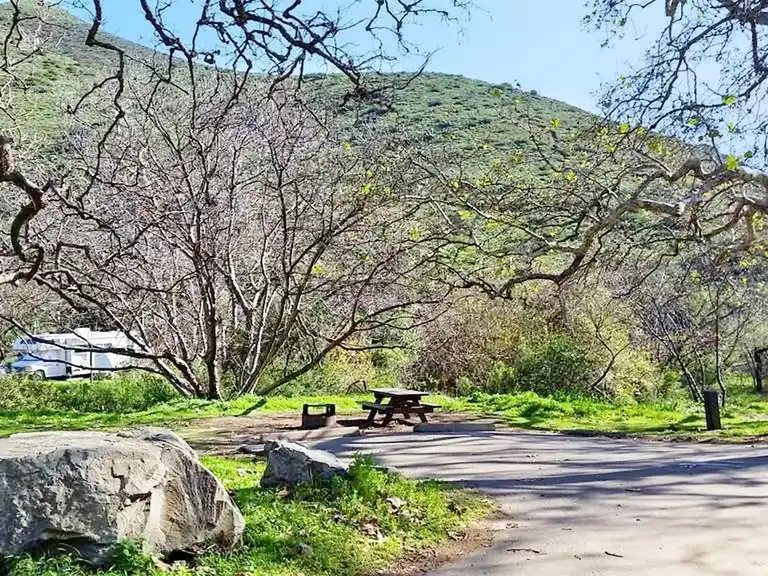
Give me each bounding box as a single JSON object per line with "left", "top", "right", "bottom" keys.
{"left": 261, "top": 440, "right": 349, "bottom": 488}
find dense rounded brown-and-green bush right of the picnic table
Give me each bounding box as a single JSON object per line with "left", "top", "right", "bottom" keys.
{"left": 411, "top": 289, "right": 669, "bottom": 400}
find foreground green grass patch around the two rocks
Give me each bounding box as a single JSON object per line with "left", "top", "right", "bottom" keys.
{"left": 4, "top": 457, "right": 491, "bottom": 576}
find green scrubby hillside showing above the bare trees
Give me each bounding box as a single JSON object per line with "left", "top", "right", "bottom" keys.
{"left": 0, "top": 4, "right": 589, "bottom": 160}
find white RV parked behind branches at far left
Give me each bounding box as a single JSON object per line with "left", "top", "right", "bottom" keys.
{"left": 10, "top": 328, "right": 132, "bottom": 378}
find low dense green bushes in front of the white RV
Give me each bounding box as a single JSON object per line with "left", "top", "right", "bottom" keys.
{"left": 0, "top": 373, "right": 179, "bottom": 413}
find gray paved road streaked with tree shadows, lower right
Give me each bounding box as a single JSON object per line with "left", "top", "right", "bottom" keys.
{"left": 315, "top": 432, "right": 768, "bottom": 576}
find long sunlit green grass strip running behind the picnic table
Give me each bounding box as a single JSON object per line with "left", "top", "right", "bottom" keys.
{"left": 0, "top": 368, "right": 768, "bottom": 439}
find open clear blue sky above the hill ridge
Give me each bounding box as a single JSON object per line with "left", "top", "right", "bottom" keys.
{"left": 82, "top": 0, "right": 662, "bottom": 110}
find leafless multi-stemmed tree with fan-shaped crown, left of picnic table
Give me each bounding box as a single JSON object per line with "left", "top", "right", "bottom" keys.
{"left": 16, "top": 79, "right": 446, "bottom": 398}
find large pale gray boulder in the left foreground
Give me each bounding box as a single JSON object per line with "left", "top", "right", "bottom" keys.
{"left": 0, "top": 428, "right": 245, "bottom": 565}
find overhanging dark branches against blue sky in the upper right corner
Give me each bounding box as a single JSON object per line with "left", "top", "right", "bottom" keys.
{"left": 586, "top": 0, "right": 768, "bottom": 162}
